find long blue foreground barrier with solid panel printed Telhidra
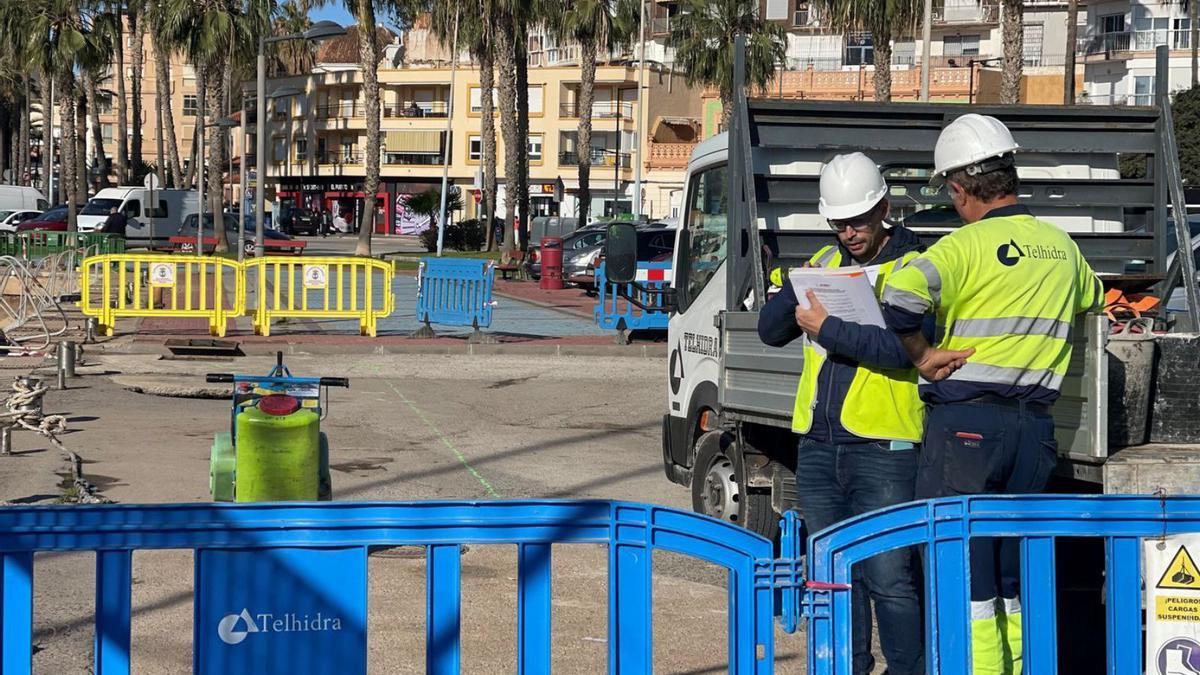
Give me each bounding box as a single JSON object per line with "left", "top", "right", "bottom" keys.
{"left": 0, "top": 501, "right": 777, "bottom": 675}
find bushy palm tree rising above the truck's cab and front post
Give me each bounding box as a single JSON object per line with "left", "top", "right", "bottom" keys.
{"left": 671, "top": 0, "right": 785, "bottom": 127}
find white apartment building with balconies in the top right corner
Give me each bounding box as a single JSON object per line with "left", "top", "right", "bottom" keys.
{"left": 1079, "top": 0, "right": 1192, "bottom": 106}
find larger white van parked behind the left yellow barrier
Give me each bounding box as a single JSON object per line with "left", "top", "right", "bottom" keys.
{"left": 77, "top": 187, "right": 200, "bottom": 245}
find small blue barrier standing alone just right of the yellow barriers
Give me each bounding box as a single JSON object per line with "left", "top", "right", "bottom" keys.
{"left": 415, "top": 258, "right": 496, "bottom": 338}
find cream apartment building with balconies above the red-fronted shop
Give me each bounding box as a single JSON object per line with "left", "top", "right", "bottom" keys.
{"left": 255, "top": 25, "right": 700, "bottom": 233}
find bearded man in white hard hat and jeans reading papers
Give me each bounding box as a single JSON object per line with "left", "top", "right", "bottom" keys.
{"left": 758, "top": 153, "right": 932, "bottom": 675}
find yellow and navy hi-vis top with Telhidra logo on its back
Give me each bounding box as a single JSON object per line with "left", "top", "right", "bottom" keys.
{"left": 883, "top": 214, "right": 1104, "bottom": 392}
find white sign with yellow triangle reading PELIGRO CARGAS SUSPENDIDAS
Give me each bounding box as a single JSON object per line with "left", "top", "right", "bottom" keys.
{"left": 1142, "top": 534, "right": 1200, "bottom": 675}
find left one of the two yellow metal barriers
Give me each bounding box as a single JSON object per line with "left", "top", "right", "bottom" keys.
{"left": 79, "top": 253, "right": 246, "bottom": 336}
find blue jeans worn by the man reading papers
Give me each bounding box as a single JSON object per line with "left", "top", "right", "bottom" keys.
{"left": 796, "top": 438, "right": 925, "bottom": 675}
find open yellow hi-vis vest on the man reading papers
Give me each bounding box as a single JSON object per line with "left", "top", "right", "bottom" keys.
{"left": 781, "top": 246, "right": 925, "bottom": 443}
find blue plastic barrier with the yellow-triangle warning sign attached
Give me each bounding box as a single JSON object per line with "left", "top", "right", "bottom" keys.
{"left": 796, "top": 495, "right": 1200, "bottom": 675}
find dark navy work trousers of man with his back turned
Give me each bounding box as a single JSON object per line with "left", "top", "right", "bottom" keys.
{"left": 917, "top": 400, "right": 1058, "bottom": 602}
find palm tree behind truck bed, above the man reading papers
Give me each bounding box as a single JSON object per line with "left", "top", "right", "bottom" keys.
{"left": 820, "top": 0, "right": 920, "bottom": 101}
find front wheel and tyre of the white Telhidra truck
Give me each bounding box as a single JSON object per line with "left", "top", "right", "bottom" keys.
{"left": 691, "top": 431, "right": 779, "bottom": 540}
